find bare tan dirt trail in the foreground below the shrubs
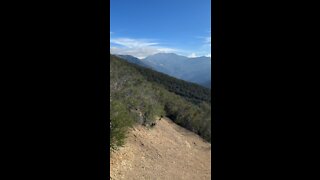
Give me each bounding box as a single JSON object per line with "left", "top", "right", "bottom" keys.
{"left": 110, "top": 119, "right": 211, "bottom": 180}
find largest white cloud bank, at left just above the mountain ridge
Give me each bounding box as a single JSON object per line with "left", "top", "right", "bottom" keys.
{"left": 110, "top": 38, "right": 178, "bottom": 59}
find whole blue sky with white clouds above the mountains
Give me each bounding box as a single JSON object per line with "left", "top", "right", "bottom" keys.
{"left": 110, "top": 0, "right": 211, "bottom": 58}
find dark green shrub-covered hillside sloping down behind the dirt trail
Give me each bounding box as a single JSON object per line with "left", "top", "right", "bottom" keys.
{"left": 110, "top": 55, "right": 211, "bottom": 148}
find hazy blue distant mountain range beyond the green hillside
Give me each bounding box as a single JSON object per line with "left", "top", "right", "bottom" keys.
{"left": 117, "top": 53, "right": 211, "bottom": 88}
